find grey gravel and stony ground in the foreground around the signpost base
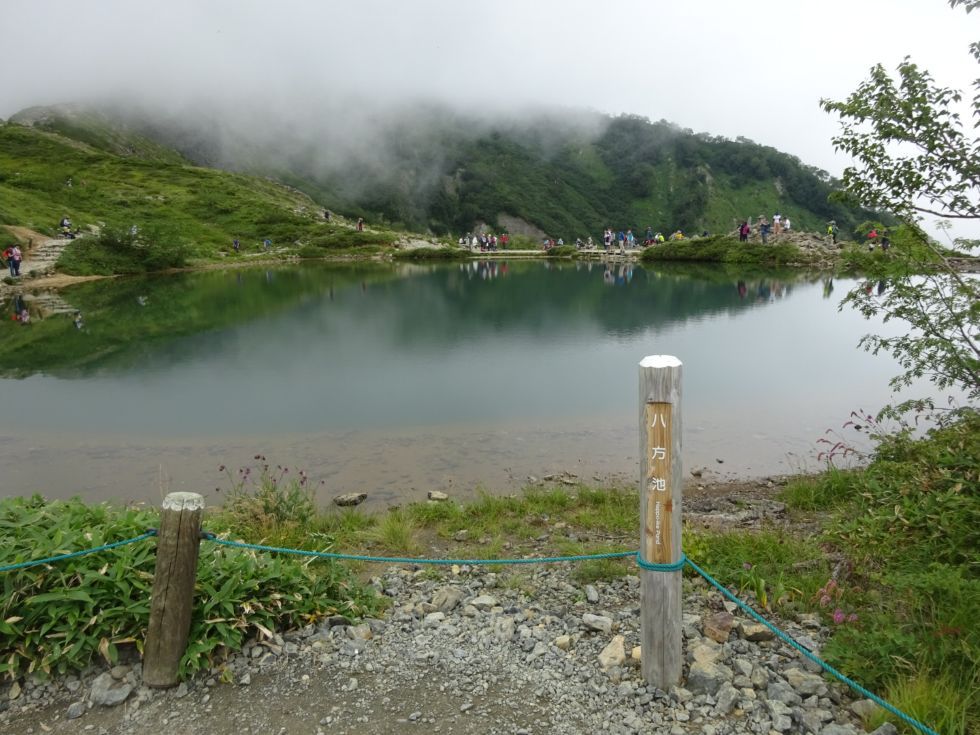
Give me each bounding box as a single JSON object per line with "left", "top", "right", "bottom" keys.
{"left": 0, "top": 552, "right": 896, "bottom": 735}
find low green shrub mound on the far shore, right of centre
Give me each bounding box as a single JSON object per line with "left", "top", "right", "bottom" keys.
{"left": 641, "top": 235, "right": 814, "bottom": 267}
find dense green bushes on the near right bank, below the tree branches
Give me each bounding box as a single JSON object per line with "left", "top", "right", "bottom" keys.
{"left": 784, "top": 412, "right": 980, "bottom": 733}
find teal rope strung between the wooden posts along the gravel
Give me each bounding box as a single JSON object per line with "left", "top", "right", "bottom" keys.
{"left": 0, "top": 528, "right": 939, "bottom": 735}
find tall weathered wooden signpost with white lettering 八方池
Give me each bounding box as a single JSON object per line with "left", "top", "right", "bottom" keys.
{"left": 640, "top": 355, "right": 683, "bottom": 690}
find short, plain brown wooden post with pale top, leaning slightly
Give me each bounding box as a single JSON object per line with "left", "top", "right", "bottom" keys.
{"left": 143, "top": 493, "right": 204, "bottom": 687}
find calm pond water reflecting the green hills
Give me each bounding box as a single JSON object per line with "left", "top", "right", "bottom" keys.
{"left": 0, "top": 262, "right": 908, "bottom": 502}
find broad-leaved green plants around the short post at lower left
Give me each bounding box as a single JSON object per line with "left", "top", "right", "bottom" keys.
{"left": 0, "top": 496, "right": 378, "bottom": 679}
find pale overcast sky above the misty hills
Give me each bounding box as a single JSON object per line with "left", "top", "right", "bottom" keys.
{"left": 0, "top": 0, "right": 980, "bottom": 227}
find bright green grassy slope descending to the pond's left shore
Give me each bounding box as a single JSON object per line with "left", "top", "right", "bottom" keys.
{"left": 0, "top": 123, "right": 395, "bottom": 272}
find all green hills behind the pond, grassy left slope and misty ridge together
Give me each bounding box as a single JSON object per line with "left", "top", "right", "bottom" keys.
{"left": 0, "top": 107, "right": 880, "bottom": 257}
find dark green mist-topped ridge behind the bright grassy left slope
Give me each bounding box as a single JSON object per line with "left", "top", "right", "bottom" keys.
{"left": 0, "top": 107, "right": 878, "bottom": 241}
